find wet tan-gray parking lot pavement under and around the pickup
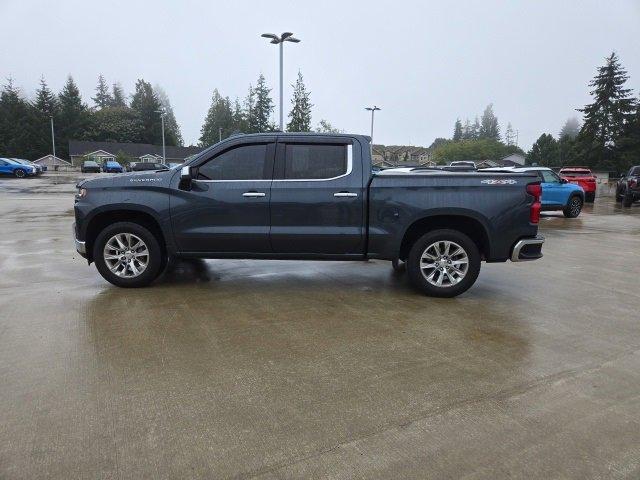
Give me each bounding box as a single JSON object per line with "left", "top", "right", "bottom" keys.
{"left": 0, "top": 174, "right": 640, "bottom": 479}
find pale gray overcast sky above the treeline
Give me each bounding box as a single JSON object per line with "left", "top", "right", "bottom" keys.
{"left": 0, "top": 0, "right": 640, "bottom": 149}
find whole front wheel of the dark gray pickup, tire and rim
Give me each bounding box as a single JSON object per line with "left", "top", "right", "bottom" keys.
{"left": 93, "top": 222, "right": 163, "bottom": 288}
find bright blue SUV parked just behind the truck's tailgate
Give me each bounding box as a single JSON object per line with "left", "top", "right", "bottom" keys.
{"left": 480, "top": 167, "right": 584, "bottom": 218}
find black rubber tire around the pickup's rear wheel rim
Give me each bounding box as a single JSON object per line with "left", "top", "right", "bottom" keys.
{"left": 406, "top": 229, "right": 480, "bottom": 298}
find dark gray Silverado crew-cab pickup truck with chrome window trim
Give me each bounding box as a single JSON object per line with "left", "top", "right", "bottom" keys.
{"left": 74, "top": 133, "right": 544, "bottom": 297}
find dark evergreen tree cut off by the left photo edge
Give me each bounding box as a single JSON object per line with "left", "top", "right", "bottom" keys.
{"left": 0, "top": 78, "right": 42, "bottom": 160}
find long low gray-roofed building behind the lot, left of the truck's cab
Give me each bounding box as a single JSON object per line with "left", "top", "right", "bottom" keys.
{"left": 69, "top": 140, "right": 203, "bottom": 166}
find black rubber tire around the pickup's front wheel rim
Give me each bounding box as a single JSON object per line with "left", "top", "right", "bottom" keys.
{"left": 93, "top": 222, "right": 166, "bottom": 288}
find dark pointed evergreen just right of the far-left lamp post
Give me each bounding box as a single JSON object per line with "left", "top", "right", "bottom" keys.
{"left": 56, "top": 75, "right": 92, "bottom": 158}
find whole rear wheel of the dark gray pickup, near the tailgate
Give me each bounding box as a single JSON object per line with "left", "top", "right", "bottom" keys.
{"left": 407, "top": 229, "right": 480, "bottom": 297}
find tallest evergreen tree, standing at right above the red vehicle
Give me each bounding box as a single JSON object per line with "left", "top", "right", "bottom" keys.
{"left": 577, "top": 52, "right": 635, "bottom": 167}
